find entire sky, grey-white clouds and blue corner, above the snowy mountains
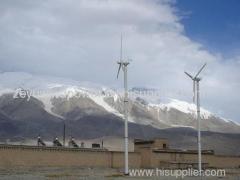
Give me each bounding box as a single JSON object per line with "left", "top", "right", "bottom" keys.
{"left": 0, "top": 0, "right": 240, "bottom": 122}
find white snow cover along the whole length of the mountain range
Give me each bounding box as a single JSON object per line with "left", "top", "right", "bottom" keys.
{"left": 0, "top": 72, "right": 240, "bottom": 131}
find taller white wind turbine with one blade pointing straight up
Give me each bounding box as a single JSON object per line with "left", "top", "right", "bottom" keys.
{"left": 117, "top": 35, "right": 129, "bottom": 175}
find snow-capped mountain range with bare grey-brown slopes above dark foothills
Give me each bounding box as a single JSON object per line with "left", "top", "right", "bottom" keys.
{"left": 0, "top": 72, "right": 240, "bottom": 133}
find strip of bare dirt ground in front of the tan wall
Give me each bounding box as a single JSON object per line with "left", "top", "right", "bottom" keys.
{"left": 0, "top": 167, "right": 240, "bottom": 180}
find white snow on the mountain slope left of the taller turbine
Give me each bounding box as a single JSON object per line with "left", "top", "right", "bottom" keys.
{"left": 0, "top": 72, "right": 122, "bottom": 117}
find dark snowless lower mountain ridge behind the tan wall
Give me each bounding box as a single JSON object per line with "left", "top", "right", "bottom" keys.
{"left": 0, "top": 91, "right": 240, "bottom": 155}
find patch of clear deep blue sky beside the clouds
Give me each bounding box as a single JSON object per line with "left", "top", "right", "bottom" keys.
{"left": 176, "top": 0, "right": 240, "bottom": 57}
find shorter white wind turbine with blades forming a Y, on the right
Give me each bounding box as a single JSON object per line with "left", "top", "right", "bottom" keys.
{"left": 184, "top": 63, "right": 207, "bottom": 175}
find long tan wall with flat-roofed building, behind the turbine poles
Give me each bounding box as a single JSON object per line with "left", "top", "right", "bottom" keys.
{"left": 0, "top": 139, "right": 240, "bottom": 169}
